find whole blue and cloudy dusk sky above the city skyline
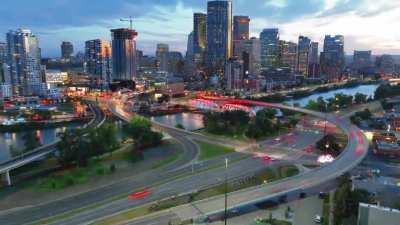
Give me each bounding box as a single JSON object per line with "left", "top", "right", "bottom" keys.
{"left": 0, "top": 0, "right": 400, "bottom": 57}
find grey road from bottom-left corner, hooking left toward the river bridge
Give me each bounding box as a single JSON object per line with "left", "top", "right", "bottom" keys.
{"left": 0, "top": 102, "right": 202, "bottom": 225}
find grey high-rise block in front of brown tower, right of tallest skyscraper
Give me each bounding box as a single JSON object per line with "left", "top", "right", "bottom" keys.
{"left": 234, "top": 38, "right": 261, "bottom": 78}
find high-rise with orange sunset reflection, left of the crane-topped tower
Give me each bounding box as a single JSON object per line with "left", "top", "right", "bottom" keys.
{"left": 85, "top": 39, "right": 112, "bottom": 86}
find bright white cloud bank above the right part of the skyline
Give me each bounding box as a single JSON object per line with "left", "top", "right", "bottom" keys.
{"left": 253, "top": 3, "right": 400, "bottom": 54}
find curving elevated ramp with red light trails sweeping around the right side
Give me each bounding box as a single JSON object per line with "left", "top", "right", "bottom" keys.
{"left": 117, "top": 98, "right": 369, "bottom": 224}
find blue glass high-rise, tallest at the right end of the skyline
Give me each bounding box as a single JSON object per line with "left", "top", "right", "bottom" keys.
{"left": 320, "top": 35, "right": 345, "bottom": 81}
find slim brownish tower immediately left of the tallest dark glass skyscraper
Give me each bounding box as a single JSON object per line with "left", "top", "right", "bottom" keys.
{"left": 193, "top": 13, "right": 207, "bottom": 65}
